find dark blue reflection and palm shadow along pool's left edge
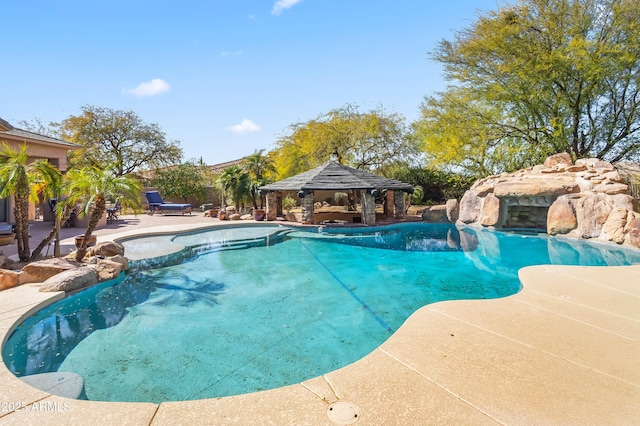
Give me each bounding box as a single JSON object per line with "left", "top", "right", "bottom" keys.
{"left": 3, "top": 271, "right": 224, "bottom": 376}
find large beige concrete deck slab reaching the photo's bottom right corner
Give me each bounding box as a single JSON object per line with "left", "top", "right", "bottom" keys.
{"left": 381, "top": 299, "right": 640, "bottom": 425}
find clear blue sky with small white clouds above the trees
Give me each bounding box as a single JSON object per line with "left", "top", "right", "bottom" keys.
{"left": 0, "top": 0, "right": 498, "bottom": 164}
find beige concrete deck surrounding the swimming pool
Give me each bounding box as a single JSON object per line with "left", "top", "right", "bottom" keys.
{"left": 0, "top": 218, "right": 640, "bottom": 425}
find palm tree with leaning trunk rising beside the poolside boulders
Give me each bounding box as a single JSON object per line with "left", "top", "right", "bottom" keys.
{"left": 63, "top": 167, "right": 142, "bottom": 262}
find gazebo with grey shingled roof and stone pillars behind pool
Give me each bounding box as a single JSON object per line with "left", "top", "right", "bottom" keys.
{"left": 259, "top": 161, "right": 413, "bottom": 225}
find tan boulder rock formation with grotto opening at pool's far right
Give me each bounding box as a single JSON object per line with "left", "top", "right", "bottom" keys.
{"left": 423, "top": 153, "right": 640, "bottom": 248}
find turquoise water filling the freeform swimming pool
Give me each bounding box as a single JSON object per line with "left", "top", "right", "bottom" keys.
{"left": 3, "top": 224, "right": 640, "bottom": 402}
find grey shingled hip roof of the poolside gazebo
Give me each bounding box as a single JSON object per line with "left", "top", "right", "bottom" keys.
{"left": 260, "top": 161, "right": 413, "bottom": 192}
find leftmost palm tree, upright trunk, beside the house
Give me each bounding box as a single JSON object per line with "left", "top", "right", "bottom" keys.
{"left": 0, "top": 142, "right": 60, "bottom": 262}
